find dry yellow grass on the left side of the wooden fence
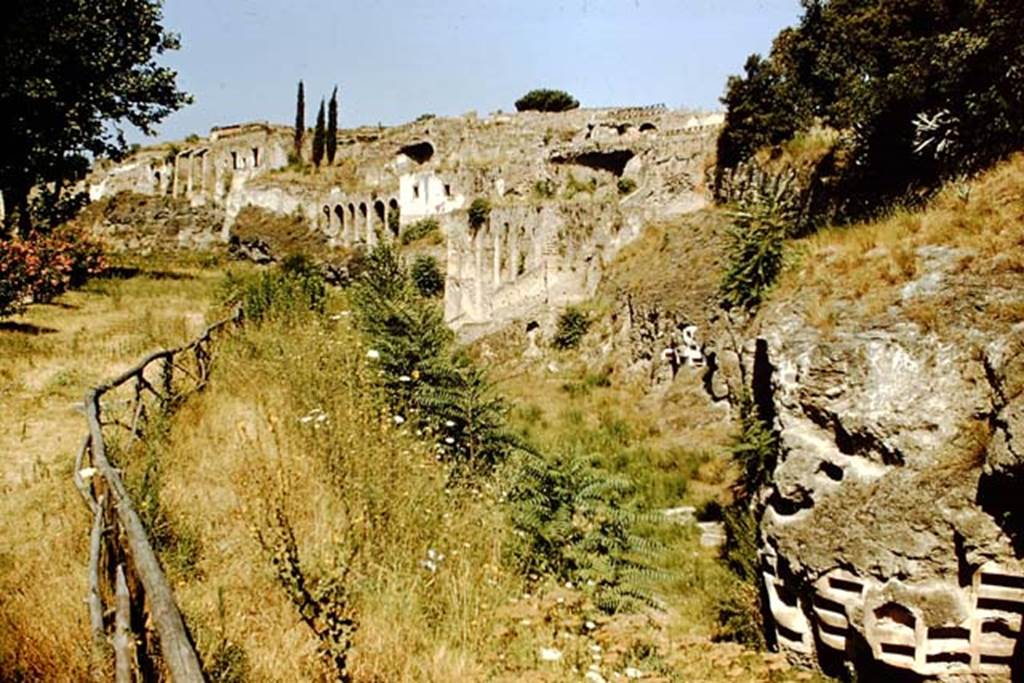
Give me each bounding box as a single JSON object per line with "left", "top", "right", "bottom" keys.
{"left": 0, "top": 260, "right": 224, "bottom": 681}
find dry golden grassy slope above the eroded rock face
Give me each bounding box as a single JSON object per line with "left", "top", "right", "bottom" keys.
{"left": 771, "top": 155, "right": 1024, "bottom": 332}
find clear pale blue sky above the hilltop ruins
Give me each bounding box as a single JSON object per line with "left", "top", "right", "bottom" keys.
{"left": 142, "top": 0, "right": 800, "bottom": 140}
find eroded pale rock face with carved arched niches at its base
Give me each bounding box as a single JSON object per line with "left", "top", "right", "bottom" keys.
{"left": 748, "top": 303, "right": 1024, "bottom": 680}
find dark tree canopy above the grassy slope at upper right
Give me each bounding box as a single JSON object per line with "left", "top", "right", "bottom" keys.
{"left": 719, "top": 0, "right": 1024, "bottom": 216}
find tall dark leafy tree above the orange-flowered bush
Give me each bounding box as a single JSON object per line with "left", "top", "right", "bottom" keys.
{"left": 0, "top": 0, "right": 190, "bottom": 231}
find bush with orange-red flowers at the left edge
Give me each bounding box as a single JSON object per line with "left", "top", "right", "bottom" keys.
{"left": 0, "top": 228, "right": 106, "bottom": 316}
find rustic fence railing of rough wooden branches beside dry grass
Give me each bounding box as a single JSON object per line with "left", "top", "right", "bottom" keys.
{"left": 73, "top": 309, "right": 242, "bottom": 683}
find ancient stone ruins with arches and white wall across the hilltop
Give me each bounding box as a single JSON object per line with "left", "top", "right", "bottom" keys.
{"left": 87, "top": 105, "right": 722, "bottom": 335}
